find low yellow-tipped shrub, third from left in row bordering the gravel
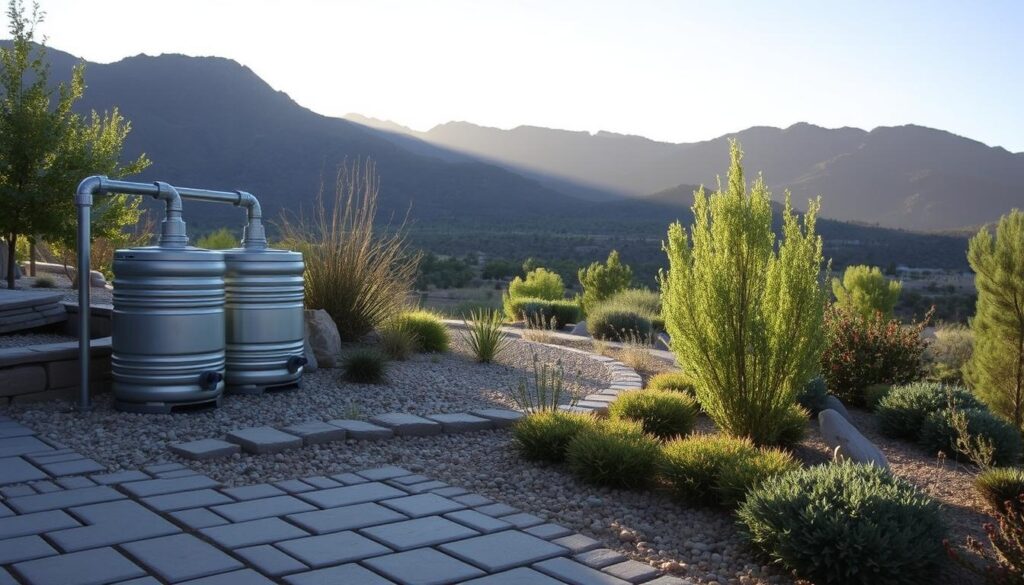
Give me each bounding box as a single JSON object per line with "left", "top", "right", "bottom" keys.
{"left": 658, "top": 434, "right": 758, "bottom": 504}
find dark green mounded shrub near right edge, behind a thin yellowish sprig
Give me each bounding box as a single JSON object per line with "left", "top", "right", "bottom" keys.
{"left": 918, "top": 408, "right": 1021, "bottom": 465}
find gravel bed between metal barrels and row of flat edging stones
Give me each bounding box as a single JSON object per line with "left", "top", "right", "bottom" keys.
{"left": 6, "top": 334, "right": 610, "bottom": 469}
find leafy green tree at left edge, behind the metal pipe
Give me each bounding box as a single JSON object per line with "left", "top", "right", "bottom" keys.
{"left": 0, "top": 0, "right": 150, "bottom": 288}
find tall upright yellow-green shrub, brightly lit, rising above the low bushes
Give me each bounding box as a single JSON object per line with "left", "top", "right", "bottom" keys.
{"left": 659, "top": 141, "right": 826, "bottom": 444}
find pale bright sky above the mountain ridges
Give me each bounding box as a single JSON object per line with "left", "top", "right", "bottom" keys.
{"left": 25, "top": 0, "right": 1024, "bottom": 152}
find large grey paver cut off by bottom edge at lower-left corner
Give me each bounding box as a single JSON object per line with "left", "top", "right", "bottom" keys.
{"left": 14, "top": 548, "right": 145, "bottom": 585}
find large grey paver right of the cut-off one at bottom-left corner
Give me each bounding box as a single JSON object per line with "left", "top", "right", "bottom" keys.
{"left": 122, "top": 534, "right": 244, "bottom": 583}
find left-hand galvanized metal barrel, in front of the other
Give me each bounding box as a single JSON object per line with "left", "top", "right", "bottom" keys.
{"left": 111, "top": 246, "right": 224, "bottom": 413}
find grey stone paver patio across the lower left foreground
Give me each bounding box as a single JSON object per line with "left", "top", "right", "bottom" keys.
{"left": 0, "top": 416, "right": 686, "bottom": 585}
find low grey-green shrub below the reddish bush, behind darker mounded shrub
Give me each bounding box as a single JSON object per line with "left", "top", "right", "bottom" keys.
{"left": 876, "top": 382, "right": 981, "bottom": 441}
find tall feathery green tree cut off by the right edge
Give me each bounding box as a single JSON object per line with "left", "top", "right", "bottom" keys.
{"left": 964, "top": 209, "right": 1024, "bottom": 428}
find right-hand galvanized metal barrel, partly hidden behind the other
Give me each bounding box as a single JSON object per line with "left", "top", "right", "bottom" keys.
{"left": 223, "top": 248, "right": 306, "bottom": 393}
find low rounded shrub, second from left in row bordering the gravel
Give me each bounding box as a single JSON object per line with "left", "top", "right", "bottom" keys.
{"left": 565, "top": 420, "right": 662, "bottom": 489}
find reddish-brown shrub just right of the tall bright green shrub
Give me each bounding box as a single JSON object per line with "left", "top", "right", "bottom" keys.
{"left": 821, "top": 305, "right": 928, "bottom": 406}
